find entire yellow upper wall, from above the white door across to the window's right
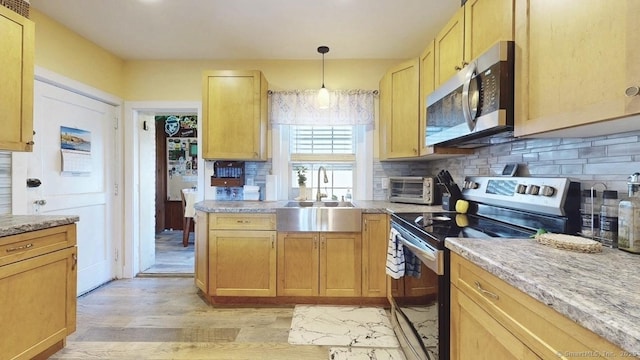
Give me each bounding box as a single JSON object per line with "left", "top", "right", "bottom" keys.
{"left": 30, "top": 9, "right": 403, "bottom": 158}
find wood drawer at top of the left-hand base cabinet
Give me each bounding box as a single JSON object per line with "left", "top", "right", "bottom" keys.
{"left": 0, "top": 224, "right": 76, "bottom": 266}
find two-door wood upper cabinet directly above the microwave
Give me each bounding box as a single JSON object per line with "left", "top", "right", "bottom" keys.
{"left": 435, "top": 0, "right": 514, "bottom": 86}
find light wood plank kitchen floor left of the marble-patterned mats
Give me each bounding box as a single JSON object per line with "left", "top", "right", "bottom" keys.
{"left": 51, "top": 277, "right": 329, "bottom": 360}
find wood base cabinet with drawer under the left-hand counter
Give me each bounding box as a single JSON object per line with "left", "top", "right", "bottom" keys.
{"left": 0, "top": 224, "right": 78, "bottom": 359}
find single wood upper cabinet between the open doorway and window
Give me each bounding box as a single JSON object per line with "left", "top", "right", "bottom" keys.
{"left": 202, "top": 70, "right": 268, "bottom": 161}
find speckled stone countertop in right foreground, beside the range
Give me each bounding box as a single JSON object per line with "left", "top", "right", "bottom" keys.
{"left": 445, "top": 238, "right": 640, "bottom": 357}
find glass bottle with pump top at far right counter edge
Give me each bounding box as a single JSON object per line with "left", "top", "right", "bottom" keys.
{"left": 618, "top": 173, "right": 640, "bottom": 254}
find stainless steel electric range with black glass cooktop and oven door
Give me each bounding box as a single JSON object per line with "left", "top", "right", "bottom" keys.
{"left": 390, "top": 177, "right": 580, "bottom": 360}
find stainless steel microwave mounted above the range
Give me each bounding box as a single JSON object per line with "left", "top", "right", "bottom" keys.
{"left": 425, "top": 41, "right": 515, "bottom": 148}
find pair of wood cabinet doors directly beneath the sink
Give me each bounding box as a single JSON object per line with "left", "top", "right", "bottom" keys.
{"left": 277, "top": 232, "right": 362, "bottom": 297}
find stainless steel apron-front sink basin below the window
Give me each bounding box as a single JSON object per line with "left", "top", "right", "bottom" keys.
{"left": 276, "top": 201, "right": 362, "bottom": 232}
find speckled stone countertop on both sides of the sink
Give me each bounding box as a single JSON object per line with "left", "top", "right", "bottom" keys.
{"left": 194, "top": 200, "right": 442, "bottom": 214}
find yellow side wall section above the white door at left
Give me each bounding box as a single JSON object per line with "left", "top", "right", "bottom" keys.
{"left": 29, "top": 7, "right": 125, "bottom": 98}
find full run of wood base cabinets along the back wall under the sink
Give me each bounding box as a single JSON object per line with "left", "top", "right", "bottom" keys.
{"left": 195, "top": 211, "right": 388, "bottom": 303}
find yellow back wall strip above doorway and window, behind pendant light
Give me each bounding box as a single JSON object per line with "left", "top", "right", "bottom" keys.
{"left": 125, "top": 59, "right": 398, "bottom": 101}
